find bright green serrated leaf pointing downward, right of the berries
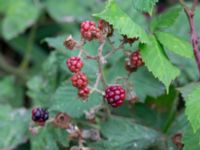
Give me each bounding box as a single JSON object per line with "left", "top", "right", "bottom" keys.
{"left": 140, "top": 36, "right": 180, "bottom": 91}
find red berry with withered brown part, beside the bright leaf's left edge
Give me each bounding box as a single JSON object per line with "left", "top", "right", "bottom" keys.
{"left": 125, "top": 50, "right": 144, "bottom": 72}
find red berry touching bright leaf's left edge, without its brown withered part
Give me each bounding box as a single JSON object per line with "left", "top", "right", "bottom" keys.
{"left": 129, "top": 51, "right": 144, "bottom": 68}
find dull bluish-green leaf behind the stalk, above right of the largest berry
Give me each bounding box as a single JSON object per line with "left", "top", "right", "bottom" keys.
{"left": 106, "top": 57, "right": 165, "bottom": 102}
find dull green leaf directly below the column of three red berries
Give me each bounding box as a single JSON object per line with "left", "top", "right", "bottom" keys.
{"left": 50, "top": 82, "right": 102, "bottom": 118}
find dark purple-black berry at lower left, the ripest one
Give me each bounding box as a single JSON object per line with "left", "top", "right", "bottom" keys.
{"left": 32, "top": 108, "right": 49, "bottom": 125}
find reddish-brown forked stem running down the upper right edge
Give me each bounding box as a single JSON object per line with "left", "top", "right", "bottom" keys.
{"left": 179, "top": 0, "right": 200, "bottom": 80}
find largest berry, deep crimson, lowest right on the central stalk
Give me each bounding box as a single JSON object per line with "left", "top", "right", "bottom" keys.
{"left": 104, "top": 85, "right": 126, "bottom": 107}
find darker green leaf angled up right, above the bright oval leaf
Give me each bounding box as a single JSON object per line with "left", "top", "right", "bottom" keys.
{"left": 151, "top": 7, "right": 182, "bottom": 31}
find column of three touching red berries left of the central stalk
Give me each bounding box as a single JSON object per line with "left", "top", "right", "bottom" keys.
{"left": 66, "top": 56, "right": 90, "bottom": 99}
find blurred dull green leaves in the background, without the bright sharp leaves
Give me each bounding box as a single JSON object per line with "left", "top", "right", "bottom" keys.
{"left": 0, "top": 0, "right": 200, "bottom": 150}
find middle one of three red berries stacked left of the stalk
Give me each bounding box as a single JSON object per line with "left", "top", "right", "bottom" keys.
{"left": 71, "top": 72, "right": 88, "bottom": 89}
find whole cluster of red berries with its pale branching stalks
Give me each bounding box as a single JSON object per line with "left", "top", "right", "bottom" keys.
{"left": 64, "top": 20, "right": 144, "bottom": 107}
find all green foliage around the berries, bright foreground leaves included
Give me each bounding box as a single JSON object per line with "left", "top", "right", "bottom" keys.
{"left": 0, "top": 0, "right": 200, "bottom": 150}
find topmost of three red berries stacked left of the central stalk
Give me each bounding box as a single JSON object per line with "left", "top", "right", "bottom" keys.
{"left": 66, "top": 56, "right": 83, "bottom": 73}
